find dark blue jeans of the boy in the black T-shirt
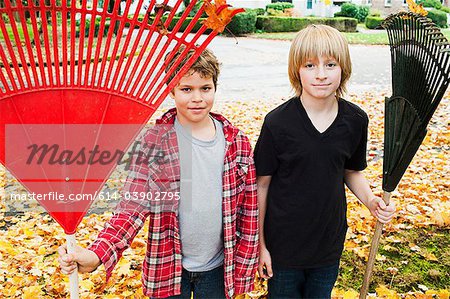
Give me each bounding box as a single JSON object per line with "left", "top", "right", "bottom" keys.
{"left": 268, "top": 263, "right": 339, "bottom": 299}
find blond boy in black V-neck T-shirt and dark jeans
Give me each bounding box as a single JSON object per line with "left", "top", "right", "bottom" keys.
{"left": 255, "top": 25, "right": 395, "bottom": 299}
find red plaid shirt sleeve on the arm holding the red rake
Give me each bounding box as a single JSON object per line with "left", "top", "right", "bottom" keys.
{"left": 88, "top": 137, "right": 150, "bottom": 280}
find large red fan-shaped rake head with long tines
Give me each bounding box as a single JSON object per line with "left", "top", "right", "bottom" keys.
{"left": 0, "top": 0, "right": 242, "bottom": 233}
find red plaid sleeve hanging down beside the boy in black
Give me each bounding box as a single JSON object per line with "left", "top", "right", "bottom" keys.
{"left": 234, "top": 150, "right": 259, "bottom": 295}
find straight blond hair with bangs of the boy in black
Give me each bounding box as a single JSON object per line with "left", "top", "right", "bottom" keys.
{"left": 288, "top": 25, "right": 352, "bottom": 98}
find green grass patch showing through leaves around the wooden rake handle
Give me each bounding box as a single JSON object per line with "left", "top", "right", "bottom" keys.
{"left": 336, "top": 226, "right": 450, "bottom": 292}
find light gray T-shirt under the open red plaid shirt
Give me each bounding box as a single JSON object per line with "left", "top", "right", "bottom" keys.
{"left": 175, "top": 119, "right": 225, "bottom": 272}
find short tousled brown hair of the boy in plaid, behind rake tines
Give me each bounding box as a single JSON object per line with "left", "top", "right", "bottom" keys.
{"left": 164, "top": 45, "right": 220, "bottom": 89}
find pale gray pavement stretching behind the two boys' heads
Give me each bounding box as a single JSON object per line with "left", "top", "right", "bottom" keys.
{"left": 204, "top": 37, "right": 391, "bottom": 100}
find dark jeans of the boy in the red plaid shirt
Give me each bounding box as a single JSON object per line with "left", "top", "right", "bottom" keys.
{"left": 164, "top": 266, "right": 226, "bottom": 299}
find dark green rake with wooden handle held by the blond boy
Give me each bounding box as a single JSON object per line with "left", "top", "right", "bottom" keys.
{"left": 359, "top": 12, "right": 450, "bottom": 299}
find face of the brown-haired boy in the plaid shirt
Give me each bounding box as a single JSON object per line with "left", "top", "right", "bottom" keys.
{"left": 170, "top": 72, "right": 216, "bottom": 125}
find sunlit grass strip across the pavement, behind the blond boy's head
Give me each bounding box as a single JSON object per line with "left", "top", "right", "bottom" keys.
{"left": 249, "top": 29, "right": 450, "bottom": 45}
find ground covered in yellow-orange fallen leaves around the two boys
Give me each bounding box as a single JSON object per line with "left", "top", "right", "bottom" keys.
{"left": 0, "top": 93, "right": 450, "bottom": 299}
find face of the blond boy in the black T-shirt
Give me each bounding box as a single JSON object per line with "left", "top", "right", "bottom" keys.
{"left": 300, "top": 56, "right": 342, "bottom": 100}
